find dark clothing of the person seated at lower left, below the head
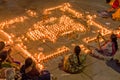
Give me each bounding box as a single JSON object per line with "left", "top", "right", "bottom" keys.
{"left": 20, "top": 62, "right": 50, "bottom": 80}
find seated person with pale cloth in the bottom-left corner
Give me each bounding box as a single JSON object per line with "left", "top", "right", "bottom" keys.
{"left": 0, "top": 51, "right": 18, "bottom": 80}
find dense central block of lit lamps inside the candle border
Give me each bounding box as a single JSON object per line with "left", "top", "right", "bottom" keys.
{"left": 27, "top": 15, "right": 85, "bottom": 42}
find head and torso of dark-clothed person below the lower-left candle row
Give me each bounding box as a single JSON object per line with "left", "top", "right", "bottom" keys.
{"left": 20, "top": 58, "right": 40, "bottom": 80}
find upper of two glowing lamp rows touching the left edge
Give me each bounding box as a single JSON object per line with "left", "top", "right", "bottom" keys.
{"left": 0, "top": 16, "right": 28, "bottom": 29}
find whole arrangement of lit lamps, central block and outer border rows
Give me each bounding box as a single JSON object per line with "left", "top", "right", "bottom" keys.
{"left": 0, "top": 3, "right": 120, "bottom": 69}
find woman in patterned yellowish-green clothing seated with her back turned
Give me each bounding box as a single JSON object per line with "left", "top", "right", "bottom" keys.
{"left": 62, "top": 46, "right": 86, "bottom": 74}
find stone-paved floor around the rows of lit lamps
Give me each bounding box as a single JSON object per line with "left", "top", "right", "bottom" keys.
{"left": 0, "top": 0, "right": 120, "bottom": 80}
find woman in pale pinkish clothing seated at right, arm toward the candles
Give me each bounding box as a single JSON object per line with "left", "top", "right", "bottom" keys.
{"left": 92, "top": 34, "right": 118, "bottom": 57}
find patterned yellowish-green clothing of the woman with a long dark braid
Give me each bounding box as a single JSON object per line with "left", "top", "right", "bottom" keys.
{"left": 63, "top": 54, "right": 86, "bottom": 74}
